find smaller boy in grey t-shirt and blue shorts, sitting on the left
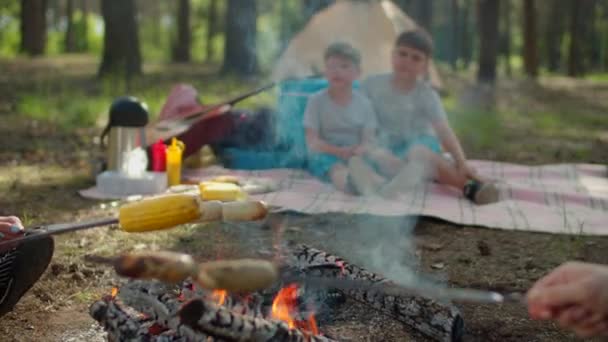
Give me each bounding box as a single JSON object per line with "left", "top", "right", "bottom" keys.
{"left": 304, "top": 43, "right": 384, "bottom": 195}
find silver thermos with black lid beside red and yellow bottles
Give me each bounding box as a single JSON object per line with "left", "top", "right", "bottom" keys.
{"left": 101, "top": 96, "right": 148, "bottom": 171}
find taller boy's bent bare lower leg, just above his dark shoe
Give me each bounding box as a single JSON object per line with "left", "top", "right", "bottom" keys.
{"left": 407, "top": 146, "right": 467, "bottom": 190}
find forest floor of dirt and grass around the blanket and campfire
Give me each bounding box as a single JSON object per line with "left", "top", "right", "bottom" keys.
{"left": 0, "top": 56, "right": 608, "bottom": 342}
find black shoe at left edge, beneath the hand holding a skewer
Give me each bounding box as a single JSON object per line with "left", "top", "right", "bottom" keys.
{"left": 0, "top": 236, "right": 54, "bottom": 317}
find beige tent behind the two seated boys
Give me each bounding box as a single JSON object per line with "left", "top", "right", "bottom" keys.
{"left": 272, "top": 0, "right": 441, "bottom": 88}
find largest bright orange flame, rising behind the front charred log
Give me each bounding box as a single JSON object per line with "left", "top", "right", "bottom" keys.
{"left": 271, "top": 284, "right": 319, "bottom": 335}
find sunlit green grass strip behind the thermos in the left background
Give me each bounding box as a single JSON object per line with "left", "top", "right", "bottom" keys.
{"left": 10, "top": 57, "right": 275, "bottom": 129}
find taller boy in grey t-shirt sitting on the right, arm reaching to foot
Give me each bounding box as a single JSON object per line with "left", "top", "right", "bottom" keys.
{"left": 363, "top": 30, "right": 498, "bottom": 204}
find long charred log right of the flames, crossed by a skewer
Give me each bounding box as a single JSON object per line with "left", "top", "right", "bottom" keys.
{"left": 292, "top": 245, "right": 464, "bottom": 341}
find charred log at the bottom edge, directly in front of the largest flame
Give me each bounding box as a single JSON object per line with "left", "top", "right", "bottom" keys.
{"left": 179, "top": 299, "right": 334, "bottom": 342}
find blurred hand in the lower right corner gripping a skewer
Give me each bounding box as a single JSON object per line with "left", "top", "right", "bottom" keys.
{"left": 527, "top": 262, "right": 608, "bottom": 337}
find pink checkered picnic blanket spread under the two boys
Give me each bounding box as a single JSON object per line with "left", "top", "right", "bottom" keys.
{"left": 81, "top": 161, "right": 608, "bottom": 235}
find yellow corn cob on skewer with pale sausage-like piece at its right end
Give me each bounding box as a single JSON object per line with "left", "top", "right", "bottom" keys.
{"left": 118, "top": 194, "right": 268, "bottom": 233}
